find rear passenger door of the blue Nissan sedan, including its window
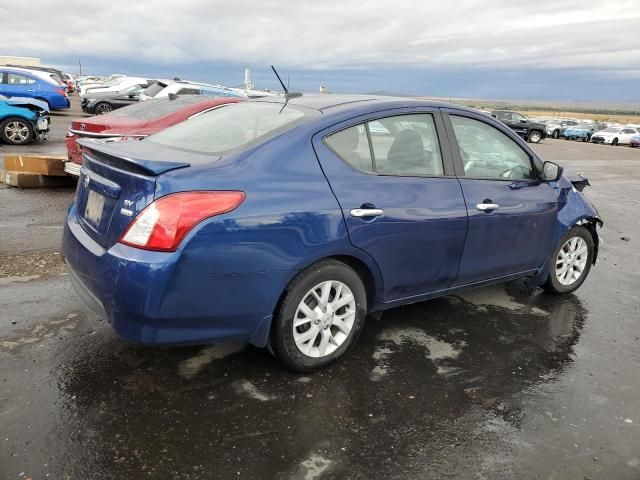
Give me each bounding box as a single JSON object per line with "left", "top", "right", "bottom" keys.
{"left": 313, "top": 109, "right": 467, "bottom": 303}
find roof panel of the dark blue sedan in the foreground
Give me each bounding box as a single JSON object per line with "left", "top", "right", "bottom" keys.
{"left": 251, "top": 93, "right": 456, "bottom": 112}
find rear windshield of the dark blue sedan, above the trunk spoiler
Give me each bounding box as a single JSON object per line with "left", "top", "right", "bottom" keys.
{"left": 144, "top": 102, "right": 318, "bottom": 154}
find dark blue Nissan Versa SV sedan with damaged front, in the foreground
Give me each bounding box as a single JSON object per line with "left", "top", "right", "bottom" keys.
{"left": 63, "top": 95, "right": 602, "bottom": 371}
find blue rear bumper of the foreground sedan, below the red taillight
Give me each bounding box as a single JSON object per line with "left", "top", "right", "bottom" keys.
{"left": 62, "top": 205, "right": 282, "bottom": 346}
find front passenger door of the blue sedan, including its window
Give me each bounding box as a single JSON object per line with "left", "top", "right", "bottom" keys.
{"left": 444, "top": 110, "right": 558, "bottom": 285}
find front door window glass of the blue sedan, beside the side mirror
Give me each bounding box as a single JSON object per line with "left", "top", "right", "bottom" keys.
{"left": 449, "top": 115, "right": 535, "bottom": 179}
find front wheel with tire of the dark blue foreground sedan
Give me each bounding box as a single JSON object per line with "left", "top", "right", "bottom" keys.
{"left": 542, "top": 226, "right": 595, "bottom": 295}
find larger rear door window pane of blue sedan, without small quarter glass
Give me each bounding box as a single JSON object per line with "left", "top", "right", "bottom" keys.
{"left": 368, "top": 114, "right": 444, "bottom": 175}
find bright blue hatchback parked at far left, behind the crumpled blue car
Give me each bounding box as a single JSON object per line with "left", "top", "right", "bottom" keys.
{"left": 0, "top": 67, "right": 71, "bottom": 110}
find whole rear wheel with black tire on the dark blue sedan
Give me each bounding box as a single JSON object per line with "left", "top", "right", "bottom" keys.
{"left": 270, "top": 260, "right": 367, "bottom": 373}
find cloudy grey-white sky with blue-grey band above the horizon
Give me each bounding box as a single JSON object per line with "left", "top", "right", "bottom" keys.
{"left": 5, "top": 0, "right": 640, "bottom": 103}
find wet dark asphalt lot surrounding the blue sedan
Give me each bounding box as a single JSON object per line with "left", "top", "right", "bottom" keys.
{"left": 0, "top": 100, "right": 640, "bottom": 479}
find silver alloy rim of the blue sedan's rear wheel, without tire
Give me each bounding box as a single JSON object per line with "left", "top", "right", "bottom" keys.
{"left": 293, "top": 280, "right": 356, "bottom": 358}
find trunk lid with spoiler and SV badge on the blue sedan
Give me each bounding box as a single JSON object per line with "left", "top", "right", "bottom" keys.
{"left": 76, "top": 139, "right": 191, "bottom": 249}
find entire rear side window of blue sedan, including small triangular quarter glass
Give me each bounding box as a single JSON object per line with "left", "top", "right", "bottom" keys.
{"left": 324, "top": 114, "right": 444, "bottom": 176}
